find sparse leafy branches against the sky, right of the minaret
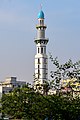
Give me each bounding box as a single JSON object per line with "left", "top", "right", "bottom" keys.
{"left": 50, "top": 54, "right": 80, "bottom": 93}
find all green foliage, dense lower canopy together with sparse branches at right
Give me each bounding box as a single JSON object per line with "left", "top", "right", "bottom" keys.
{"left": 0, "top": 55, "right": 80, "bottom": 120}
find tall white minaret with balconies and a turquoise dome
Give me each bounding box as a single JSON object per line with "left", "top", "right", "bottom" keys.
{"left": 34, "top": 10, "right": 48, "bottom": 89}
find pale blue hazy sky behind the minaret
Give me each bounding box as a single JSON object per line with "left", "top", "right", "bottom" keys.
{"left": 0, "top": 0, "right": 80, "bottom": 83}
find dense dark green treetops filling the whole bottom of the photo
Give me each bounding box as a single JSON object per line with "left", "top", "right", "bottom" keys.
{"left": 1, "top": 86, "right": 80, "bottom": 120}
